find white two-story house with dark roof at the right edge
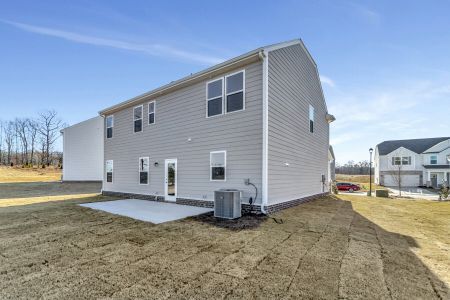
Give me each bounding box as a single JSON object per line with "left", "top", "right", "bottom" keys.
{"left": 374, "top": 137, "right": 450, "bottom": 188}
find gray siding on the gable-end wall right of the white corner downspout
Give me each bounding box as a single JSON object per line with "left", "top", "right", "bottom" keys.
{"left": 268, "top": 45, "right": 329, "bottom": 204}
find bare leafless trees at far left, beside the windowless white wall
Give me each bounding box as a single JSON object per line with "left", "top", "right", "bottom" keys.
{"left": 0, "top": 110, "right": 65, "bottom": 168}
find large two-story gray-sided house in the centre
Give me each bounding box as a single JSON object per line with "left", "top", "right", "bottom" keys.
{"left": 100, "top": 40, "right": 334, "bottom": 211}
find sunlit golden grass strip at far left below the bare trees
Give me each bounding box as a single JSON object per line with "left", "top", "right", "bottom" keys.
{"left": 0, "top": 166, "right": 61, "bottom": 183}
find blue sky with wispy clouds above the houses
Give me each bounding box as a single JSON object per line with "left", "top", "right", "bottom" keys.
{"left": 0, "top": 0, "right": 450, "bottom": 163}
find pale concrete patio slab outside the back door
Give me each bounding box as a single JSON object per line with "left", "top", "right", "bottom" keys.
{"left": 80, "top": 199, "right": 213, "bottom": 224}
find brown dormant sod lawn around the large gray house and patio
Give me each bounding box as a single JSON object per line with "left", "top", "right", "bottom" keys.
{"left": 0, "top": 185, "right": 450, "bottom": 299}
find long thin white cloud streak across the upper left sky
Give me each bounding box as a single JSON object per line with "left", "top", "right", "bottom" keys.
{"left": 0, "top": 20, "right": 223, "bottom": 64}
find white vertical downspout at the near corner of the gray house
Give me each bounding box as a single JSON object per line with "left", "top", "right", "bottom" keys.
{"left": 259, "top": 50, "right": 269, "bottom": 215}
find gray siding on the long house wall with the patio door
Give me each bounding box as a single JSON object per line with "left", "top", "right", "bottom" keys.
{"left": 103, "top": 62, "right": 262, "bottom": 201}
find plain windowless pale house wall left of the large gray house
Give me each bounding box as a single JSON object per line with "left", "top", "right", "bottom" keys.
{"left": 61, "top": 116, "right": 104, "bottom": 181}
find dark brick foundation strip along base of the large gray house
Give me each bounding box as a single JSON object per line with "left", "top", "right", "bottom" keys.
{"left": 102, "top": 191, "right": 329, "bottom": 214}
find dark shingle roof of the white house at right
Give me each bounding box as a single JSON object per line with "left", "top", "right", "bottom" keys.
{"left": 377, "top": 137, "right": 450, "bottom": 155}
